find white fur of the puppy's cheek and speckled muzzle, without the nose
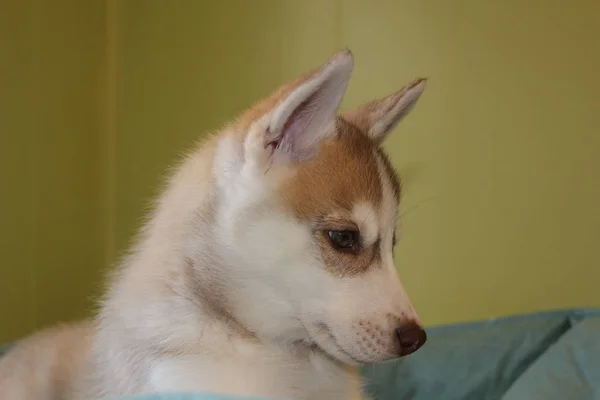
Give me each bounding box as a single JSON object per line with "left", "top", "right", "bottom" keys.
{"left": 209, "top": 198, "right": 416, "bottom": 364}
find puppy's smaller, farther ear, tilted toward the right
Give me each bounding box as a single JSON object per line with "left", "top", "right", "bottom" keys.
{"left": 342, "top": 78, "right": 427, "bottom": 144}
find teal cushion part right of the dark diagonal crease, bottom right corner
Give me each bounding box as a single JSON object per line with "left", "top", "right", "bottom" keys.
{"left": 502, "top": 317, "right": 600, "bottom": 400}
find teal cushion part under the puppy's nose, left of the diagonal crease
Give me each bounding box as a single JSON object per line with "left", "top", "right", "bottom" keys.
{"left": 363, "top": 312, "right": 570, "bottom": 400}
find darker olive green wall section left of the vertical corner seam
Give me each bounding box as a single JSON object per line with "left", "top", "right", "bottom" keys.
{"left": 0, "top": 0, "right": 106, "bottom": 343}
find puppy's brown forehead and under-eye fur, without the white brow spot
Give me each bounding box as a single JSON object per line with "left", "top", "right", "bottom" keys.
{"left": 282, "top": 118, "right": 390, "bottom": 276}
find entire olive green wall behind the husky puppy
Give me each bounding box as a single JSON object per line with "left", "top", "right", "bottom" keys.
{"left": 0, "top": 0, "right": 600, "bottom": 339}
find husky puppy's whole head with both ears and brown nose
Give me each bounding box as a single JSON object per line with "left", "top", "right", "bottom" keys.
{"left": 205, "top": 51, "right": 426, "bottom": 364}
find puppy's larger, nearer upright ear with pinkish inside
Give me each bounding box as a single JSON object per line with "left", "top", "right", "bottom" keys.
{"left": 265, "top": 50, "right": 354, "bottom": 162}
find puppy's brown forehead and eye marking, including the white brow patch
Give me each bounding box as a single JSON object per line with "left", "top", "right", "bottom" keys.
{"left": 281, "top": 118, "right": 400, "bottom": 276}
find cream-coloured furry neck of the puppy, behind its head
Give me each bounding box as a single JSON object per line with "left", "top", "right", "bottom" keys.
{"left": 99, "top": 135, "right": 290, "bottom": 347}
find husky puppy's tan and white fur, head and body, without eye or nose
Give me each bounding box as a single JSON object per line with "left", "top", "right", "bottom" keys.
{"left": 0, "top": 51, "right": 432, "bottom": 400}
